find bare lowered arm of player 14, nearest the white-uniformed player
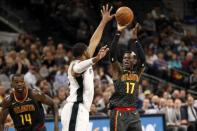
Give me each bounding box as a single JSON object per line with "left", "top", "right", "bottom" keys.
{"left": 32, "top": 89, "right": 59, "bottom": 131}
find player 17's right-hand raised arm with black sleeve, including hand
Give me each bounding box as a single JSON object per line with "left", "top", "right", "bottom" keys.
{"left": 131, "top": 23, "right": 146, "bottom": 77}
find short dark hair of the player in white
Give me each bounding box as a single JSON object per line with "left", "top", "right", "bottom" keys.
{"left": 72, "top": 43, "right": 88, "bottom": 57}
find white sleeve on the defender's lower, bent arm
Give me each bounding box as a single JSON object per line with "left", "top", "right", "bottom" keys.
{"left": 73, "top": 58, "right": 93, "bottom": 73}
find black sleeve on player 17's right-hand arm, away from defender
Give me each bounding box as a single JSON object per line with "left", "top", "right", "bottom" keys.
{"left": 135, "top": 41, "right": 146, "bottom": 67}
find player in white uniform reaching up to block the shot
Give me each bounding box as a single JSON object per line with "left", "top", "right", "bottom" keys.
{"left": 61, "top": 5, "right": 113, "bottom": 131}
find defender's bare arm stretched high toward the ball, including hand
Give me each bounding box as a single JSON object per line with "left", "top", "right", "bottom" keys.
{"left": 88, "top": 5, "right": 114, "bottom": 57}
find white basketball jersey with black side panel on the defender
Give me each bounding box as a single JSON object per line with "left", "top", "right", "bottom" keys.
{"left": 66, "top": 60, "right": 94, "bottom": 111}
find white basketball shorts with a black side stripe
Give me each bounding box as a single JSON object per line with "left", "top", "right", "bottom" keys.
{"left": 61, "top": 103, "right": 89, "bottom": 131}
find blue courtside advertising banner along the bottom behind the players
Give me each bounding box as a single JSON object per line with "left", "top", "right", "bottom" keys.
{"left": 9, "top": 114, "right": 165, "bottom": 131}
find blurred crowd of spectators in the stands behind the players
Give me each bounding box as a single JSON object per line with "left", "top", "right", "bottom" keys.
{"left": 0, "top": 2, "right": 197, "bottom": 131}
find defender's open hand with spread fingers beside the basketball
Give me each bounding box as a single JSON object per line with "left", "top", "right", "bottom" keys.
{"left": 101, "top": 4, "right": 114, "bottom": 23}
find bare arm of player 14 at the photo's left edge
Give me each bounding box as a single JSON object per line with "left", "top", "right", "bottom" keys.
{"left": 0, "top": 97, "right": 10, "bottom": 131}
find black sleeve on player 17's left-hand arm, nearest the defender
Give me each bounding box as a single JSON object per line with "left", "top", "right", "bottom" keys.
{"left": 110, "top": 31, "right": 121, "bottom": 63}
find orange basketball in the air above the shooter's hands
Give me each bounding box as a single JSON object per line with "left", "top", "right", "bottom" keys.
{"left": 115, "top": 6, "right": 134, "bottom": 26}
